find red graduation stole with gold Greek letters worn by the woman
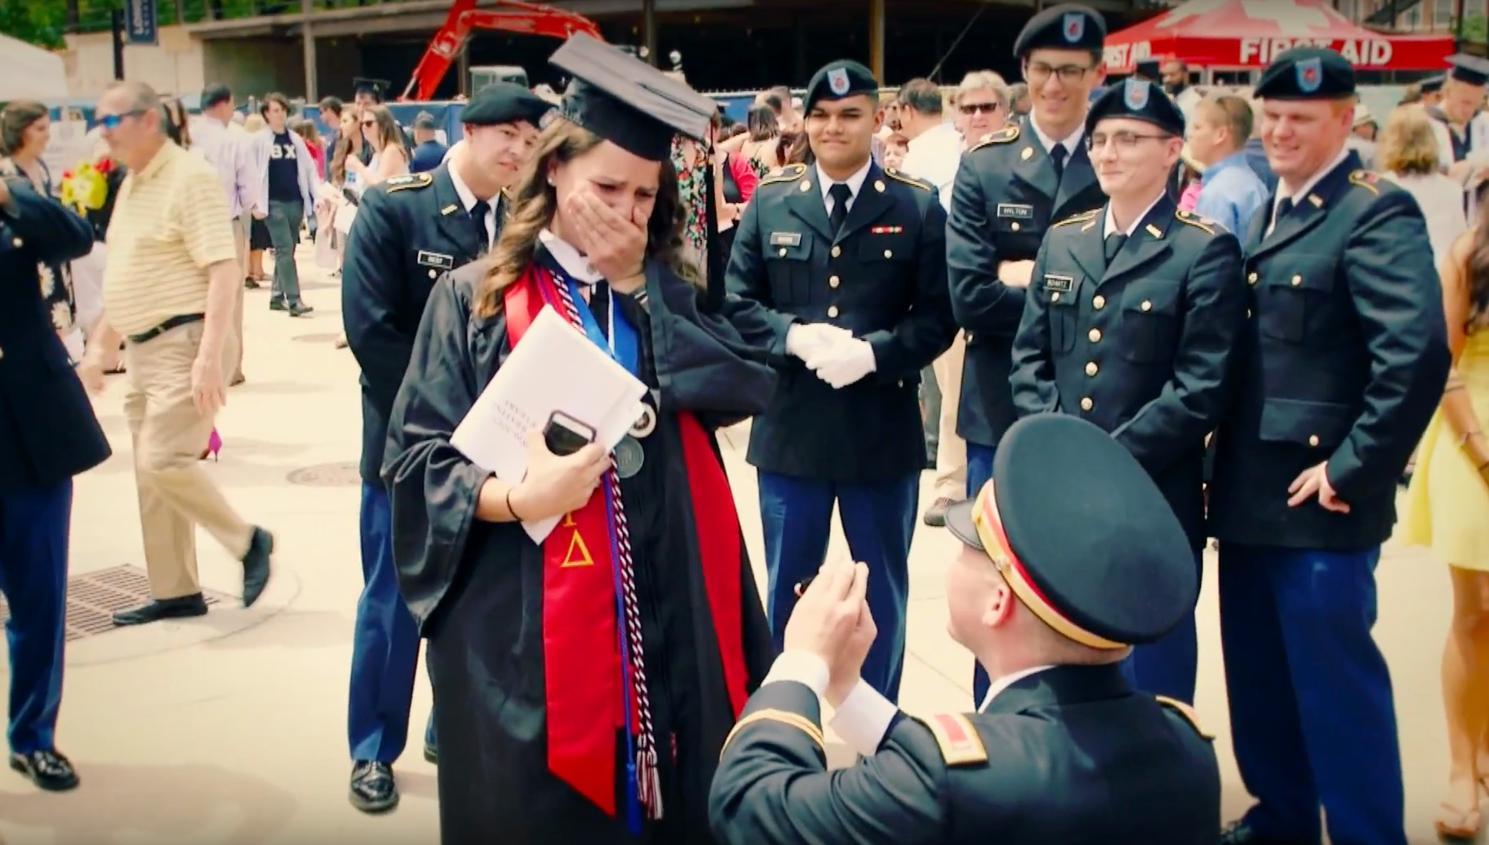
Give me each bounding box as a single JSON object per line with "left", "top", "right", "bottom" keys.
{"left": 503, "top": 268, "right": 747, "bottom": 817}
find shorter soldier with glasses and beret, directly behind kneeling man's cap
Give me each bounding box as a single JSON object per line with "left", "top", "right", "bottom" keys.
{"left": 1011, "top": 77, "right": 1246, "bottom": 702}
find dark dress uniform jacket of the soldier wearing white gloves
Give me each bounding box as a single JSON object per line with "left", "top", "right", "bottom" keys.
{"left": 725, "top": 164, "right": 956, "bottom": 483}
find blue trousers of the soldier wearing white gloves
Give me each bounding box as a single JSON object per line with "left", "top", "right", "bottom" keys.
{"left": 759, "top": 472, "right": 920, "bottom": 700}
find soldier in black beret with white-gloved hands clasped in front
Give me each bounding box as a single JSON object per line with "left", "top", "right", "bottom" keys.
{"left": 727, "top": 61, "right": 956, "bottom": 699}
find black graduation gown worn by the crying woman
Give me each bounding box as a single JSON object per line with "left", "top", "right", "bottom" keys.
{"left": 384, "top": 250, "right": 774, "bottom": 844}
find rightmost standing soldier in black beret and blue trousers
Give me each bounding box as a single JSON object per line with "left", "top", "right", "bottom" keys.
{"left": 1209, "top": 48, "right": 1449, "bottom": 844}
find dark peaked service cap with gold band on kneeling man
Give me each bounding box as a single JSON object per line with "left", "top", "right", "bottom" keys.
{"left": 946, "top": 413, "right": 1199, "bottom": 648}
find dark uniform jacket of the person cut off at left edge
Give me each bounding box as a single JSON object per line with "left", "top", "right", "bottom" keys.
{"left": 0, "top": 179, "right": 110, "bottom": 493}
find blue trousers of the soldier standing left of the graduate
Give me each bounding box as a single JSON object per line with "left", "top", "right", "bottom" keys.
{"left": 347, "top": 483, "right": 433, "bottom": 763}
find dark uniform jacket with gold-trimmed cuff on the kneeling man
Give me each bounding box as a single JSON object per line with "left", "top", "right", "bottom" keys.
{"left": 709, "top": 666, "right": 1219, "bottom": 845}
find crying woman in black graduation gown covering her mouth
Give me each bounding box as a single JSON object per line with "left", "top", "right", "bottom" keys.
{"left": 383, "top": 42, "right": 773, "bottom": 844}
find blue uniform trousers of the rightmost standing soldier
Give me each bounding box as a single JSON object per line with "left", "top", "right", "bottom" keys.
{"left": 1219, "top": 542, "right": 1406, "bottom": 845}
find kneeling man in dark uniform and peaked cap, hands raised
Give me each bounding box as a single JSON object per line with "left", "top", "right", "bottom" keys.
{"left": 710, "top": 414, "right": 1219, "bottom": 845}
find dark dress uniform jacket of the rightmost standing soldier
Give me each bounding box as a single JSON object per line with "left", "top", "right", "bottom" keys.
{"left": 1211, "top": 154, "right": 1449, "bottom": 550}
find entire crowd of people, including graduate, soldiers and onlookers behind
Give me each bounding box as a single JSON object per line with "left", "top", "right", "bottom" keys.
{"left": 0, "top": 4, "right": 1489, "bottom": 845}
